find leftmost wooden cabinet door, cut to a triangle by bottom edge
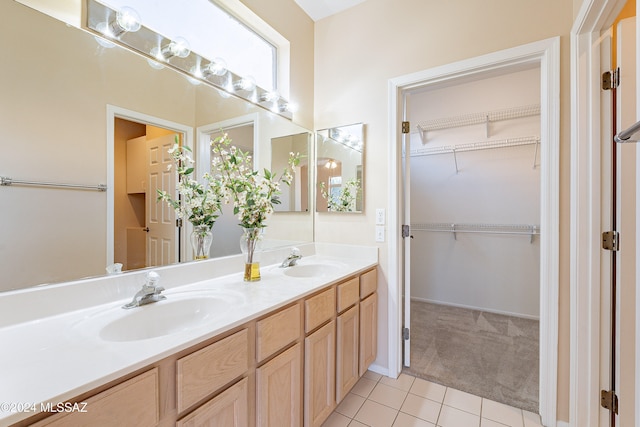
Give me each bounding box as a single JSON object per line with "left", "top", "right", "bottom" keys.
{"left": 176, "top": 378, "right": 249, "bottom": 427}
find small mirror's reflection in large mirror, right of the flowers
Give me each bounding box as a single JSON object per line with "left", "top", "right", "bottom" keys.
{"left": 271, "top": 132, "right": 311, "bottom": 212}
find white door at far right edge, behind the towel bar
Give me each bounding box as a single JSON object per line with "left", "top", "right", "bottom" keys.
{"left": 614, "top": 18, "right": 637, "bottom": 426}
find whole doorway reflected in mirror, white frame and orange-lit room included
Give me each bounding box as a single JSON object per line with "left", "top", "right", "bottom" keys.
{"left": 107, "top": 105, "right": 193, "bottom": 271}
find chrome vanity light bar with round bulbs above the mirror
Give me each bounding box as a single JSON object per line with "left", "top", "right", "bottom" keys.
{"left": 84, "top": 0, "right": 294, "bottom": 120}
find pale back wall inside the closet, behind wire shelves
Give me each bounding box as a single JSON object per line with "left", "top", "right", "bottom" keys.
{"left": 409, "top": 68, "right": 544, "bottom": 318}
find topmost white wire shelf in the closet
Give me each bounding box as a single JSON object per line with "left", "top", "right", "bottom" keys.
{"left": 417, "top": 104, "right": 540, "bottom": 139}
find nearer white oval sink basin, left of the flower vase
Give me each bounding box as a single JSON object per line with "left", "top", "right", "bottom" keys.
{"left": 78, "top": 293, "right": 241, "bottom": 342}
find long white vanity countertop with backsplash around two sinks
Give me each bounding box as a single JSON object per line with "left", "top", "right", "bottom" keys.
{"left": 0, "top": 244, "right": 377, "bottom": 426}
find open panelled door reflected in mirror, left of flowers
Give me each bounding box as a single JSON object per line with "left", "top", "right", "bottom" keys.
{"left": 146, "top": 134, "right": 178, "bottom": 266}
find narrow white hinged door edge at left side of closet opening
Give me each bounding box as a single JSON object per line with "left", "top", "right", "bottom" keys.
{"left": 402, "top": 92, "right": 411, "bottom": 366}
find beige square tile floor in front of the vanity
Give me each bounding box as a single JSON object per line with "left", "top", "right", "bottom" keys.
{"left": 322, "top": 371, "right": 542, "bottom": 427}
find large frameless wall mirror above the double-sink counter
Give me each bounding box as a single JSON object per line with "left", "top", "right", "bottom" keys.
{"left": 0, "top": 1, "right": 313, "bottom": 291}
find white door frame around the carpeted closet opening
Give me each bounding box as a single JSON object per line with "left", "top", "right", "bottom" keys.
{"left": 388, "top": 37, "right": 560, "bottom": 427}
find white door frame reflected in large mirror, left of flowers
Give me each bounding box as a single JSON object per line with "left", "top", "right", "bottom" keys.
{"left": 105, "top": 104, "right": 193, "bottom": 265}
